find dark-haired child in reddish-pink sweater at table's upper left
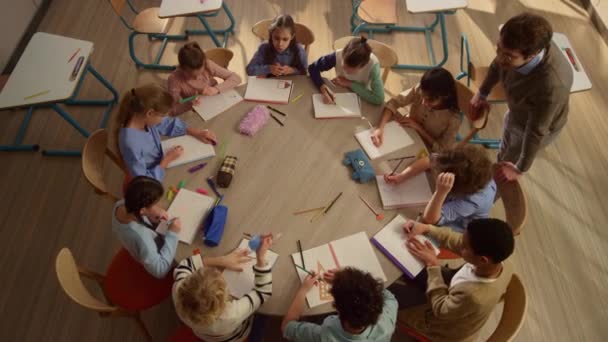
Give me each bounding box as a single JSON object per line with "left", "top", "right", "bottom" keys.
{"left": 168, "top": 42, "right": 241, "bottom": 116}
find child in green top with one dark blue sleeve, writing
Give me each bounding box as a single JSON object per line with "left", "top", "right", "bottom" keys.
{"left": 308, "top": 37, "right": 384, "bottom": 105}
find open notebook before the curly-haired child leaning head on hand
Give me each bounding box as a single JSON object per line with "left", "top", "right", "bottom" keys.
{"left": 376, "top": 172, "right": 433, "bottom": 210}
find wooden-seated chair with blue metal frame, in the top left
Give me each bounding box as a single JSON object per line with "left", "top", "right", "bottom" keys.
{"left": 109, "top": 0, "right": 188, "bottom": 70}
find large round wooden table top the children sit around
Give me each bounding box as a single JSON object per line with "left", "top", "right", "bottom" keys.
{"left": 162, "top": 76, "right": 424, "bottom": 315}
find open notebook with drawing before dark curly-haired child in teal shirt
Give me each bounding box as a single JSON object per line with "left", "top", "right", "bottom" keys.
{"left": 291, "top": 232, "right": 386, "bottom": 308}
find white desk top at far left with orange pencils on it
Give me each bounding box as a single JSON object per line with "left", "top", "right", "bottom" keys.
{"left": 0, "top": 32, "right": 93, "bottom": 108}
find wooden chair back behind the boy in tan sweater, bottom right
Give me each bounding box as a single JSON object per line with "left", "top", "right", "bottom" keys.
{"left": 487, "top": 274, "right": 528, "bottom": 342}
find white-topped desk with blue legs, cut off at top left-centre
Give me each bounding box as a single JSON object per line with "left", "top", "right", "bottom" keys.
{"left": 158, "top": 0, "right": 235, "bottom": 47}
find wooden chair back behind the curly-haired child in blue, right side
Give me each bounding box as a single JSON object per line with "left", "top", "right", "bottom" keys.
{"left": 496, "top": 176, "right": 528, "bottom": 236}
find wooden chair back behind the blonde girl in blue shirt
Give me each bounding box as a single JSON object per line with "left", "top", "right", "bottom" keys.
{"left": 82, "top": 129, "right": 126, "bottom": 202}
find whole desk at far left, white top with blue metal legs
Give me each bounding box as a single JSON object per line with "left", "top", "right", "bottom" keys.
{"left": 0, "top": 32, "right": 118, "bottom": 156}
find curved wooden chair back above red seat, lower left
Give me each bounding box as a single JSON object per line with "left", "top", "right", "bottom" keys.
{"left": 55, "top": 248, "right": 118, "bottom": 313}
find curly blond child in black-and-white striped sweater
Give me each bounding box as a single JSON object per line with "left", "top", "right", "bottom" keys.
{"left": 173, "top": 235, "right": 272, "bottom": 342}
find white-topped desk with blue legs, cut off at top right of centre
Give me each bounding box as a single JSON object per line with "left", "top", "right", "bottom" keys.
{"left": 351, "top": 0, "right": 468, "bottom": 70}
